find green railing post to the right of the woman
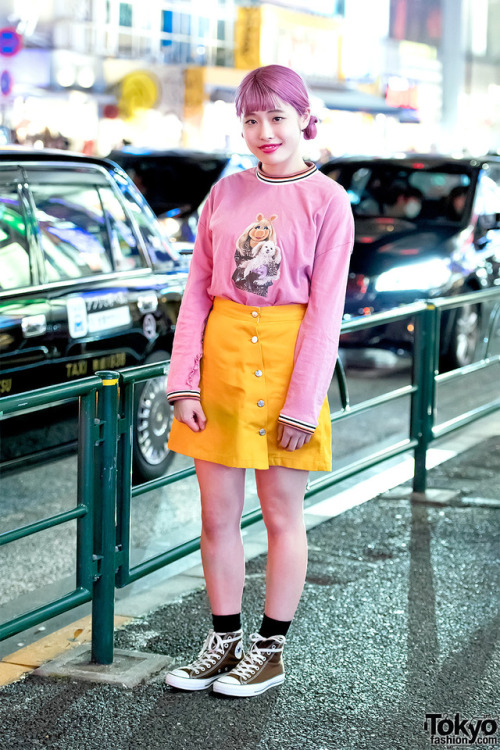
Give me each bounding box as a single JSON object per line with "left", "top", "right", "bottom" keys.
{"left": 412, "top": 302, "right": 439, "bottom": 494}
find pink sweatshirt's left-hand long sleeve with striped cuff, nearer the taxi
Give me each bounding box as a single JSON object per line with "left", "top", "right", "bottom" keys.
{"left": 167, "top": 198, "right": 213, "bottom": 401}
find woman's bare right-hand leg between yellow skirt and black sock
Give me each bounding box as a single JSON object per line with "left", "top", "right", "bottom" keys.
{"left": 255, "top": 466, "right": 309, "bottom": 621}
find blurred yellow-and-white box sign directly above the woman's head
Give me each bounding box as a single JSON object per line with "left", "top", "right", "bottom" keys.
{"left": 235, "top": 4, "right": 342, "bottom": 81}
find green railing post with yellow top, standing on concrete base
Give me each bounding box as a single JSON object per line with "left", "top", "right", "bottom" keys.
{"left": 91, "top": 371, "right": 119, "bottom": 664}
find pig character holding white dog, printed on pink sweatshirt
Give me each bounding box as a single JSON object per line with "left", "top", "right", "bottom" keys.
{"left": 232, "top": 214, "right": 281, "bottom": 297}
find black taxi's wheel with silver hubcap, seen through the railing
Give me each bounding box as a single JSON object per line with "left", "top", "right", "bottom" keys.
{"left": 133, "top": 351, "right": 173, "bottom": 480}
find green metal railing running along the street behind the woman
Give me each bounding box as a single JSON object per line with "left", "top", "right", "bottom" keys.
{"left": 0, "top": 290, "right": 500, "bottom": 664}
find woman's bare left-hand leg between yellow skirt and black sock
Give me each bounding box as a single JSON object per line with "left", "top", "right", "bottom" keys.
{"left": 195, "top": 459, "right": 245, "bottom": 615}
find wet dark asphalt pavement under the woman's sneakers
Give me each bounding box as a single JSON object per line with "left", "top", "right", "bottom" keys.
{"left": 0, "top": 437, "right": 500, "bottom": 750}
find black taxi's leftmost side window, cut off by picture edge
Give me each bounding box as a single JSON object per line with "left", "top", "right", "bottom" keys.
{"left": 0, "top": 182, "right": 31, "bottom": 290}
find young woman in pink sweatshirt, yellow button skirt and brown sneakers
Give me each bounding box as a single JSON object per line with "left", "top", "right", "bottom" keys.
{"left": 166, "top": 65, "right": 353, "bottom": 696}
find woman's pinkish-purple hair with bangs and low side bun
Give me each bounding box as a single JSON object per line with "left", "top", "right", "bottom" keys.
{"left": 235, "top": 65, "right": 318, "bottom": 140}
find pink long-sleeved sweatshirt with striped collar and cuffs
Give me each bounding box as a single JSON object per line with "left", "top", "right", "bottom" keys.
{"left": 167, "top": 163, "right": 354, "bottom": 433}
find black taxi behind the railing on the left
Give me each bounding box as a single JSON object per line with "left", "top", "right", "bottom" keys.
{"left": 0, "top": 147, "right": 188, "bottom": 478}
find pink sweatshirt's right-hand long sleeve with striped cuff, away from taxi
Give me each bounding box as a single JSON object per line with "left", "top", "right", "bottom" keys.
{"left": 279, "top": 195, "right": 354, "bottom": 433}
